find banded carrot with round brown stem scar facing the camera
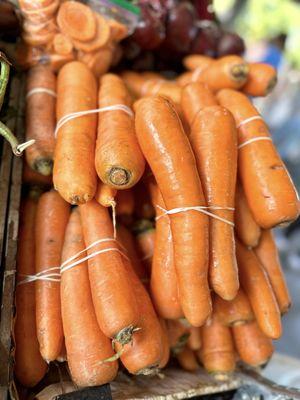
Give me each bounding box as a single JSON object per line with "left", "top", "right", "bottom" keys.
{"left": 95, "top": 74, "right": 145, "bottom": 189}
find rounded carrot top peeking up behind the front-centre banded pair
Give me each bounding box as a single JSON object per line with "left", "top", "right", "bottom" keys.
{"left": 181, "top": 82, "right": 218, "bottom": 126}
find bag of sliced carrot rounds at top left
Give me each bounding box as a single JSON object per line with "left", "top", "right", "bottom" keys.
{"left": 19, "top": 0, "right": 127, "bottom": 76}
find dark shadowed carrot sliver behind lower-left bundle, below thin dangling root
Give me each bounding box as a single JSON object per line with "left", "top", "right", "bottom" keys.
{"left": 117, "top": 224, "right": 149, "bottom": 283}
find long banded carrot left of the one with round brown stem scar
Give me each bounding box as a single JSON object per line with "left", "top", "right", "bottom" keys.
{"left": 53, "top": 61, "right": 97, "bottom": 204}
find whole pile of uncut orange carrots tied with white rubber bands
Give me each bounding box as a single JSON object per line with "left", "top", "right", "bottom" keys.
{"left": 14, "top": 53, "right": 299, "bottom": 386}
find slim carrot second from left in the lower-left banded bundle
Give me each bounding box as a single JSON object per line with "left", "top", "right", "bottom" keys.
{"left": 35, "top": 190, "right": 70, "bottom": 362}
